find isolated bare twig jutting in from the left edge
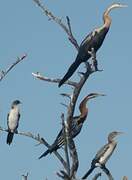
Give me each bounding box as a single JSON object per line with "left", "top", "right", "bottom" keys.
{"left": 0, "top": 54, "right": 27, "bottom": 81}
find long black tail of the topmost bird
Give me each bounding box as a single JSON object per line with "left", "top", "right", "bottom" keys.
{"left": 58, "top": 60, "right": 81, "bottom": 87}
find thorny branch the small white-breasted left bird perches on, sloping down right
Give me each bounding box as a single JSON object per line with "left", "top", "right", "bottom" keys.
{"left": 0, "top": 127, "right": 67, "bottom": 169}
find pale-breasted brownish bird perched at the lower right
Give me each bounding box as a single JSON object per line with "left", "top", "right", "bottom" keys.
{"left": 82, "top": 131, "right": 122, "bottom": 179}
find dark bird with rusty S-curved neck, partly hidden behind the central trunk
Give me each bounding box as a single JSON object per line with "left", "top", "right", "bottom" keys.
{"left": 39, "top": 93, "right": 104, "bottom": 159}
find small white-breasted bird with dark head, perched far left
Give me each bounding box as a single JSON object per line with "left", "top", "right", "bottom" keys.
{"left": 6, "top": 100, "right": 21, "bottom": 145}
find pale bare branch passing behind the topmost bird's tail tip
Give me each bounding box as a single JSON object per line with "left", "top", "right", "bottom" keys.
{"left": 32, "top": 72, "right": 77, "bottom": 86}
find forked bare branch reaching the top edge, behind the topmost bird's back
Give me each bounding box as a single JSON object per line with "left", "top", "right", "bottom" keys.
{"left": 33, "top": 0, "right": 79, "bottom": 50}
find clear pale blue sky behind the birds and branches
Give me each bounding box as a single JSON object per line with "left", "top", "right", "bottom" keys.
{"left": 0, "top": 0, "right": 132, "bottom": 180}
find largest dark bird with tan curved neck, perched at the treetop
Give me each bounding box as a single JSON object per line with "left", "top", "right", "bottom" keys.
{"left": 58, "top": 3, "right": 126, "bottom": 87}
